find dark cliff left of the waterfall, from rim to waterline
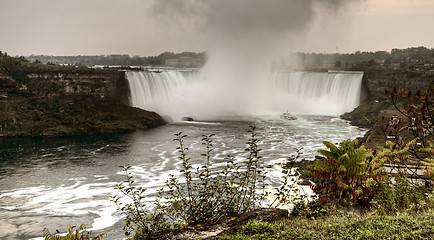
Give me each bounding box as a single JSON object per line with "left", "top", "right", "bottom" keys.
{"left": 0, "top": 69, "right": 165, "bottom": 136}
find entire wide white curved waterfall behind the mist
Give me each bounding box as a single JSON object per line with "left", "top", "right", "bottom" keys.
{"left": 126, "top": 70, "right": 363, "bottom": 120}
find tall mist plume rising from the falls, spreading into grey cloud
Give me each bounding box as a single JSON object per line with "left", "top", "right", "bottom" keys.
{"left": 147, "top": 0, "right": 366, "bottom": 119}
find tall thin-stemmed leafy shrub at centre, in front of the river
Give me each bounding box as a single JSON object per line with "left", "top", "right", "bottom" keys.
{"left": 165, "top": 127, "right": 266, "bottom": 224}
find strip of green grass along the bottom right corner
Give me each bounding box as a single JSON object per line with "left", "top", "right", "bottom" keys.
{"left": 222, "top": 208, "right": 434, "bottom": 240}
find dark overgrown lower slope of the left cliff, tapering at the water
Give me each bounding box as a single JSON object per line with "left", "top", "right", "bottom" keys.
{"left": 0, "top": 95, "right": 165, "bottom": 137}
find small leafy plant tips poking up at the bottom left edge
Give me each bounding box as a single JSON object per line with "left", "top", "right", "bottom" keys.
{"left": 42, "top": 224, "right": 106, "bottom": 240}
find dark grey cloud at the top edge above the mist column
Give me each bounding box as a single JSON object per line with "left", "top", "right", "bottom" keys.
{"left": 151, "top": 0, "right": 363, "bottom": 34}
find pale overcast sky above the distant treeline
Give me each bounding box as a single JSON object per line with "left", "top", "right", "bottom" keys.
{"left": 0, "top": 0, "right": 434, "bottom": 56}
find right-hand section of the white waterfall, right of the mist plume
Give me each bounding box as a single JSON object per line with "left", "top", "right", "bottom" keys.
{"left": 270, "top": 71, "right": 363, "bottom": 115}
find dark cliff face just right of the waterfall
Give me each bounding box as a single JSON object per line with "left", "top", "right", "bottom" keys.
{"left": 363, "top": 70, "right": 434, "bottom": 100}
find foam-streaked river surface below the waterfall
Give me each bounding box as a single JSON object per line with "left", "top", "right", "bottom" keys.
{"left": 0, "top": 115, "right": 366, "bottom": 239}
